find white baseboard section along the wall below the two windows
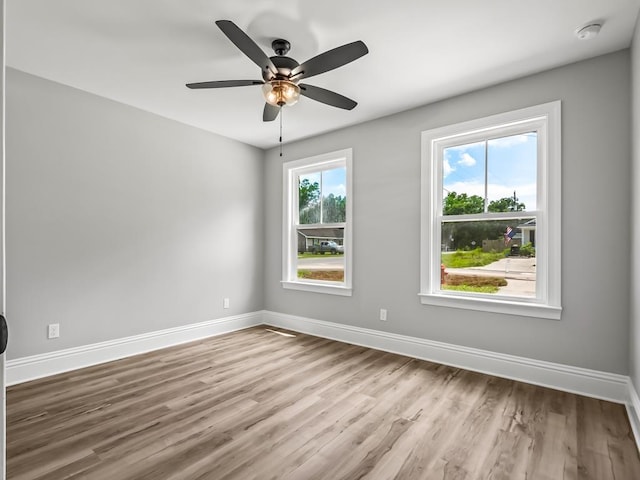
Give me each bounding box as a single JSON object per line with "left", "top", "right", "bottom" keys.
{"left": 263, "top": 311, "right": 640, "bottom": 404}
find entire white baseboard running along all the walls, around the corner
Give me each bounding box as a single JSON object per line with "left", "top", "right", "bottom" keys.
{"left": 6, "top": 311, "right": 640, "bottom": 406}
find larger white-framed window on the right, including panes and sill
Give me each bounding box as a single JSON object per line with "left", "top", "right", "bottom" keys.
{"left": 420, "top": 102, "right": 561, "bottom": 319}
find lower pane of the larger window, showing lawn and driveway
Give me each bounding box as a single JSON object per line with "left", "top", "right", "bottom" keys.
{"left": 440, "top": 217, "right": 536, "bottom": 298}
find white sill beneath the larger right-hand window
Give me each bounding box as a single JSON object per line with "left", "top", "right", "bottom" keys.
{"left": 418, "top": 293, "right": 562, "bottom": 320}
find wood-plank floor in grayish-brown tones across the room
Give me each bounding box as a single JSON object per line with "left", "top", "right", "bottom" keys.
{"left": 7, "top": 327, "right": 640, "bottom": 480}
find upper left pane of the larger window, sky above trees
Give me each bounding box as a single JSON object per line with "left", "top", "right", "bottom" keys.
{"left": 442, "top": 142, "right": 485, "bottom": 215}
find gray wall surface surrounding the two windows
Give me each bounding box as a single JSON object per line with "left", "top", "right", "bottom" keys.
{"left": 265, "top": 50, "right": 631, "bottom": 374}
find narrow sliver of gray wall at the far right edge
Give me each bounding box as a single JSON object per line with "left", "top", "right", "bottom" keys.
{"left": 629, "top": 17, "right": 640, "bottom": 392}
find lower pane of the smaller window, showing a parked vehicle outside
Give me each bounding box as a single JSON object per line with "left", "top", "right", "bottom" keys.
{"left": 297, "top": 228, "right": 344, "bottom": 282}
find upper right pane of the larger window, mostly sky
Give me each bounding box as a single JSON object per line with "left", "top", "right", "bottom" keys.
{"left": 487, "top": 132, "right": 538, "bottom": 212}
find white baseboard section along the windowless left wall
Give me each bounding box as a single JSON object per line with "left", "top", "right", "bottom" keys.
{"left": 6, "top": 312, "right": 262, "bottom": 385}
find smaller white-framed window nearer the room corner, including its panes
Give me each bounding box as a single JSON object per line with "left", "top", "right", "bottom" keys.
{"left": 282, "top": 149, "right": 352, "bottom": 295}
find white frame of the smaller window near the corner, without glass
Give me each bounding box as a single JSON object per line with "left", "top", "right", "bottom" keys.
{"left": 281, "top": 148, "right": 353, "bottom": 296}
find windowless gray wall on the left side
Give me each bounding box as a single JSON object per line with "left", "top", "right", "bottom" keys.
{"left": 6, "top": 69, "right": 264, "bottom": 359}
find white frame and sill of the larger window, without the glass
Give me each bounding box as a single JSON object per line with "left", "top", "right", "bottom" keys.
{"left": 419, "top": 101, "right": 562, "bottom": 320}
